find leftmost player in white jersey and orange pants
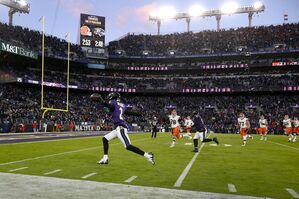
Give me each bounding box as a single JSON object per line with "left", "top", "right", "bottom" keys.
{"left": 168, "top": 109, "right": 183, "bottom": 148}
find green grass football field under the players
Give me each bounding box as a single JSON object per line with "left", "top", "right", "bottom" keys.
{"left": 0, "top": 133, "right": 299, "bottom": 199}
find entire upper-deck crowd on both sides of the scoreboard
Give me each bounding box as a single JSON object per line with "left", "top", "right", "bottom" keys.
{"left": 0, "top": 22, "right": 299, "bottom": 60}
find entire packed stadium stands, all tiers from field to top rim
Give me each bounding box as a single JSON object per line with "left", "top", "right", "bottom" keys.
{"left": 0, "top": 21, "right": 299, "bottom": 133}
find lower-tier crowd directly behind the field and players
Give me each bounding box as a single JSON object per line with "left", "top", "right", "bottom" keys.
{"left": 0, "top": 85, "right": 299, "bottom": 133}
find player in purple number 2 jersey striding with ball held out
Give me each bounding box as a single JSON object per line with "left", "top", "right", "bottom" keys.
{"left": 91, "top": 93, "right": 155, "bottom": 165}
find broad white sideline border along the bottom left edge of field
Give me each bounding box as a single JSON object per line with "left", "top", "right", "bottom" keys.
{"left": 0, "top": 173, "right": 265, "bottom": 199}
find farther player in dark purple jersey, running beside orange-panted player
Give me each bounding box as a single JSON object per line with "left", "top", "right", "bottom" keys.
{"left": 192, "top": 113, "right": 219, "bottom": 153}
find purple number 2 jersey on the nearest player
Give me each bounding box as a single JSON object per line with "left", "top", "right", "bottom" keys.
{"left": 109, "top": 100, "right": 128, "bottom": 128}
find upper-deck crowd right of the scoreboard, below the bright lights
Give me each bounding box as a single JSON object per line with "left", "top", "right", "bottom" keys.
{"left": 109, "top": 24, "right": 299, "bottom": 56}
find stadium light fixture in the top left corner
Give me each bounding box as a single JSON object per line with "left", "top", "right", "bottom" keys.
{"left": 0, "top": 0, "right": 30, "bottom": 26}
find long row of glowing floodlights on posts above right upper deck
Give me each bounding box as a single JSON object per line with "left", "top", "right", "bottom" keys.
{"left": 149, "top": 2, "right": 266, "bottom": 35}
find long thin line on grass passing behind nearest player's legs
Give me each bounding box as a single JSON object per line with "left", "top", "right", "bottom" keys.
{"left": 0, "top": 138, "right": 148, "bottom": 166}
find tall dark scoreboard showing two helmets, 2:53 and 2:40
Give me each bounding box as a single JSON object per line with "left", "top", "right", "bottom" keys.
{"left": 80, "top": 14, "right": 105, "bottom": 49}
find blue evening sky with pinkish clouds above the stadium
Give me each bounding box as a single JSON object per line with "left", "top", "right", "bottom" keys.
{"left": 0, "top": 0, "right": 299, "bottom": 43}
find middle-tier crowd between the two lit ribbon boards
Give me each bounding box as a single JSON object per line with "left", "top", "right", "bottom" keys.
{"left": 5, "top": 66, "right": 299, "bottom": 92}
